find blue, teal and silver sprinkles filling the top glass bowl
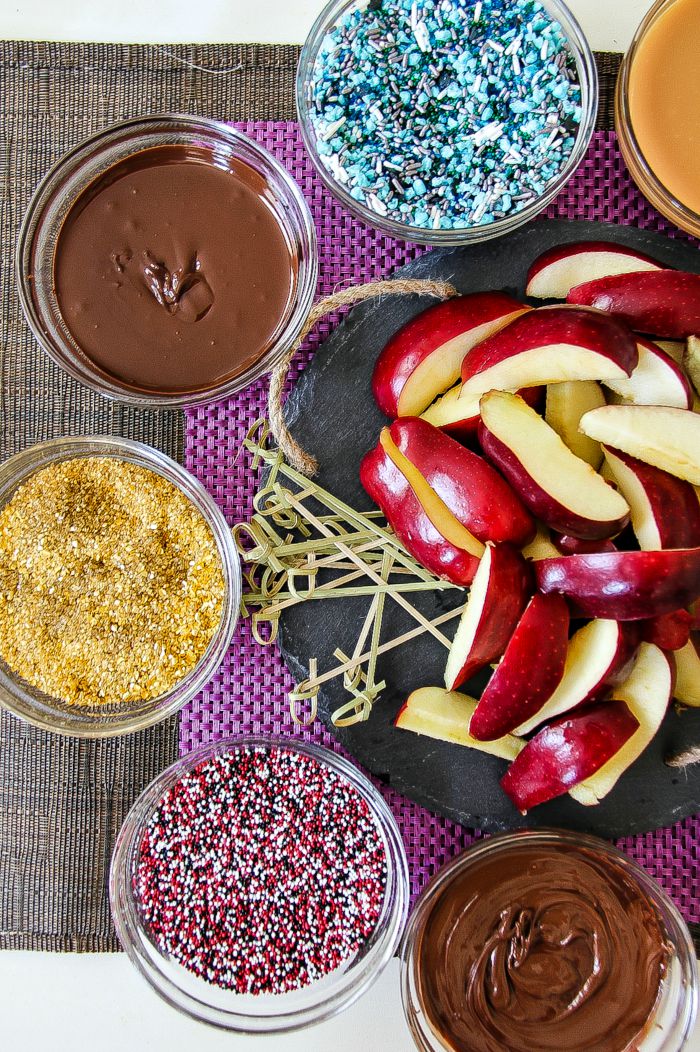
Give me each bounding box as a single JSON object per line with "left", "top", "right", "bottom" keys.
{"left": 311, "top": 0, "right": 581, "bottom": 230}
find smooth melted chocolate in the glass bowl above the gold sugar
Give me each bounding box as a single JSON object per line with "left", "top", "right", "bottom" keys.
{"left": 54, "top": 145, "right": 297, "bottom": 395}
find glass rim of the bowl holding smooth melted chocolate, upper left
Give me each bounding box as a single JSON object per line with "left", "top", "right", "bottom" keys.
{"left": 15, "top": 113, "right": 319, "bottom": 408}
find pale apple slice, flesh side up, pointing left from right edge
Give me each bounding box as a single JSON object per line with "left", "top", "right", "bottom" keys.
{"left": 581, "top": 405, "right": 700, "bottom": 486}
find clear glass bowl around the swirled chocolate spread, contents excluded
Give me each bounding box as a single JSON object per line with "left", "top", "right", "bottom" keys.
{"left": 401, "top": 829, "right": 698, "bottom": 1052}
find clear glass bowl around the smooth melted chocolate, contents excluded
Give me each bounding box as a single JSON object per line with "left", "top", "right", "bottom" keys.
{"left": 16, "top": 114, "right": 318, "bottom": 408}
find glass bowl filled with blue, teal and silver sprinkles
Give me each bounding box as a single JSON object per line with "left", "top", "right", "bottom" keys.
{"left": 296, "top": 0, "right": 598, "bottom": 245}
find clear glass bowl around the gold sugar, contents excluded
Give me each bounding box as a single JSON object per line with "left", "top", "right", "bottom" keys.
{"left": 0, "top": 438, "right": 241, "bottom": 737}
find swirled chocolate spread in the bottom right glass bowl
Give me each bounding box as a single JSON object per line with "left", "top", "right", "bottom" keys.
{"left": 418, "top": 844, "right": 668, "bottom": 1052}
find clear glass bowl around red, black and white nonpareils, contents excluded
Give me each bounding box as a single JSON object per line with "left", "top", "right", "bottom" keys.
{"left": 109, "top": 735, "right": 408, "bottom": 1034}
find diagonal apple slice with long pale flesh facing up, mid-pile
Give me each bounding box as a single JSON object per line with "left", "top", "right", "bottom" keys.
{"left": 479, "top": 391, "right": 629, "bottom": 540}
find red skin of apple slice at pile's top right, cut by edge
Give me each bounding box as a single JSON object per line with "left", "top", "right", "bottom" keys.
{"left": 566, "top": 270, "right": 700, "bottom": 340}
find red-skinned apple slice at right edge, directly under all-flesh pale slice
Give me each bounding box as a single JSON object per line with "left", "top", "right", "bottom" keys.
{"left": 605, "top": 448, "right": 700, "bottom": 551}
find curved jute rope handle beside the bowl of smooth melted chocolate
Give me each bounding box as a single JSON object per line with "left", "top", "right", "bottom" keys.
{"left": 267, "top": 279, "right": 459, "bottom": 478}
